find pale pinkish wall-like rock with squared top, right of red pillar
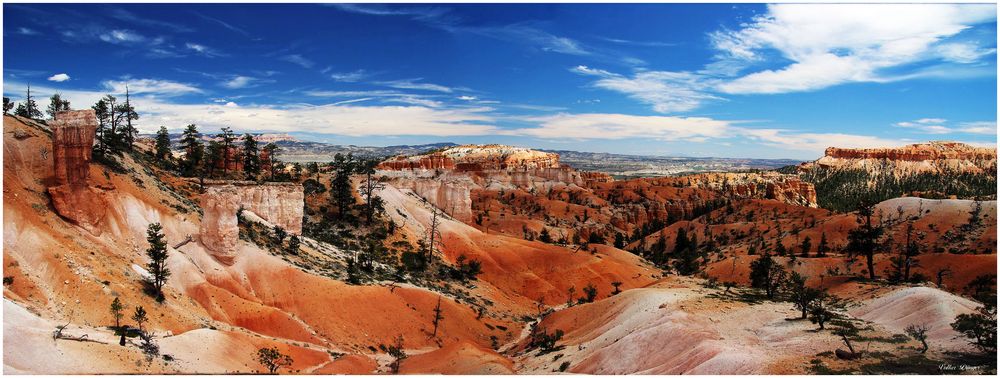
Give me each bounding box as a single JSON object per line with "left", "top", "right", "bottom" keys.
{"left": 200, "top": 181, "right": 305, "bottom": 263}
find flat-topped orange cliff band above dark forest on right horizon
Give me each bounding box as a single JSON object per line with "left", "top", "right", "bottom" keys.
{"left": 799, "top": 142, "right": 997, "bottom": 176}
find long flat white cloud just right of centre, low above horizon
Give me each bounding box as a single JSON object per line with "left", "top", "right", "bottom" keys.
{"left": 514, "top": 113, "right": 730, "bottom": 141}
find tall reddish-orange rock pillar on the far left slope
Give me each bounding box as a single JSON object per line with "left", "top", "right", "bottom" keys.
{"left": 48, "top": 109, "right": 107, "bottom": 236}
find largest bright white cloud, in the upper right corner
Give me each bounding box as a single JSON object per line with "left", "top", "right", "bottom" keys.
{"left": 710, "top": 4, "right": 996, "bottom": 94}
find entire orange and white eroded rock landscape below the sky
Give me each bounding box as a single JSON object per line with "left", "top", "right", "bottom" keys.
{"left": 3, "top": 111, "right": 997, "bottom": 374}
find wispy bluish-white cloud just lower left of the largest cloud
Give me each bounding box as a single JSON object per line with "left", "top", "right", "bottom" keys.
{"left": 571, "top": 66, "right": 720, "bottom": 113}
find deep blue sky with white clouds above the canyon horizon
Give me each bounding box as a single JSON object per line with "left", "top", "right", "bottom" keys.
{"left": 3, "top": 4, "right": 997, "bottom": 159}
